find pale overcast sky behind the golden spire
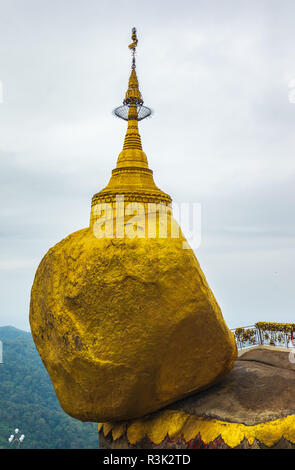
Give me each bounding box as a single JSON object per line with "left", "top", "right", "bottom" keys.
{"left": 0, "top": 0, "right": 295, "bottom": 329}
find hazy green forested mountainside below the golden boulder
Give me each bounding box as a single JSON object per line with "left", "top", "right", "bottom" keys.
{"left": 0, "top": 326, "right": 98, "bottom": 449}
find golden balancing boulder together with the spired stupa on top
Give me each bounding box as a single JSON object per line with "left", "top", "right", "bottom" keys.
{"left": 30, "top": 28, "right": 237, "bottom": 422}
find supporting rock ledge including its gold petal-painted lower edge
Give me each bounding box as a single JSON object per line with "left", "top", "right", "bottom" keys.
{"left": 99, "top": 348, "right": 295, "bottom": 449}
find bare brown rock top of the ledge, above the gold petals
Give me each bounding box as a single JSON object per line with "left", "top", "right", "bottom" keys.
{"left": 169, "top": 347, "right": 295, "bottom": 425}
